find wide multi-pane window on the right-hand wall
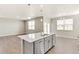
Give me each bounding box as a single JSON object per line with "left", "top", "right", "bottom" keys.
{"left": 57, "top": 19, "right": 73, "bottom": 30}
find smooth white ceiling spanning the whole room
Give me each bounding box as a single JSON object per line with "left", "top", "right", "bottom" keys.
{"left": 0, "top": 4, "right": 79, "bottom": 18}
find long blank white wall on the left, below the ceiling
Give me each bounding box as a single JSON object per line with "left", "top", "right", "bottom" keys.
{"left": 0, "top": 19, "right": 24, "bottom": 36}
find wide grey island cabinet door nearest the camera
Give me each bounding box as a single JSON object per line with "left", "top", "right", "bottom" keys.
{"left": 35, "top": 39, "right": 44, "bottom": 54}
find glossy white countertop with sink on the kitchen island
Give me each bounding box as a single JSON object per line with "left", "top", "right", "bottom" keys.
{"left": 18, "top": 33, "right": 52, "bottom": 43}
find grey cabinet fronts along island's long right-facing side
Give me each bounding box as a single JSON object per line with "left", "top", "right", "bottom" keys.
{"left": 35, "top": 35, "right": 53, "bottom": 54}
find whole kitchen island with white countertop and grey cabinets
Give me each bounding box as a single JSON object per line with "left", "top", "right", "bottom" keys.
{"left": 18, "top": 33, "right": 55, "bottom": 54}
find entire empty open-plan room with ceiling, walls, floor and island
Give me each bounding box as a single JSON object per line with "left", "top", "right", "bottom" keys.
{"left": 0, "top": 4, "right": 79, "bottom": 54}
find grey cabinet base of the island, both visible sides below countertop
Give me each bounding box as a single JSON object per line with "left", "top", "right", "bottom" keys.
{"left": 23, "top": 35, "right": 54, "bottom": 54}
